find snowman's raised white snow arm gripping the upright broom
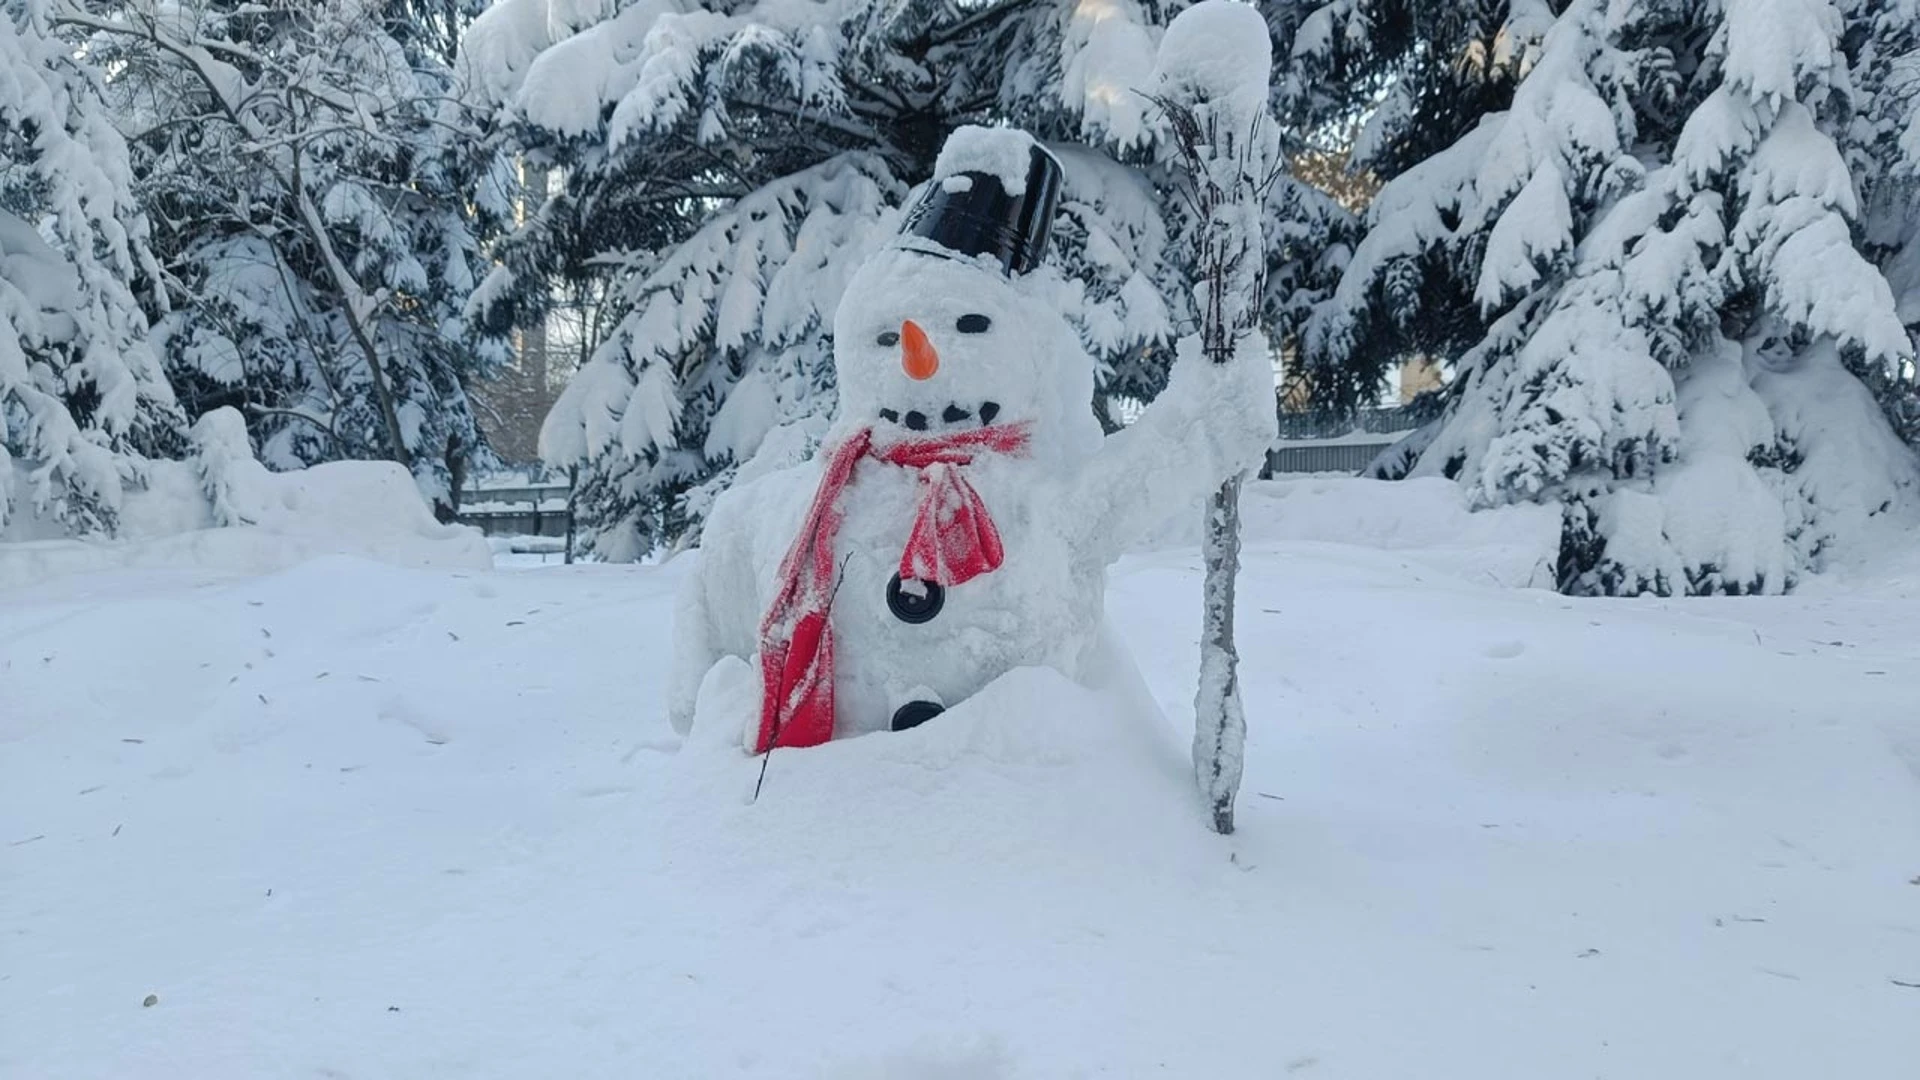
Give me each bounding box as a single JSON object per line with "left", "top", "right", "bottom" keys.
{"left": 1071, "top": 334, "right": 1279, "bottom": 563}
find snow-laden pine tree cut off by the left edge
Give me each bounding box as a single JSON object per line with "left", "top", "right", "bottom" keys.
{"left": 0, "top": 0, "right": 186, "bottom": 534}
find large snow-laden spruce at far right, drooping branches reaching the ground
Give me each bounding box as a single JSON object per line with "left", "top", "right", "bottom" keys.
{"left": 1308, "top": 0, "right": 1914, "bottom": 594}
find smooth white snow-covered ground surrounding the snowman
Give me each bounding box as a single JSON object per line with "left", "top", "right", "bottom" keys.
{"left": 0, "top": 480, "right": 1920, "bottom": 1080}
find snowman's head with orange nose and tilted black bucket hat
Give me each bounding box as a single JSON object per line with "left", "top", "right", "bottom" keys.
{"left": 833, "top": 127, "right": 1100, "bottom": 457}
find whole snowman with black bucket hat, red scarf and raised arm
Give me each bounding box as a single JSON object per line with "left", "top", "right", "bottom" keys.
{"left": 670, "top": 127, "right": 1275, "bottom": 751}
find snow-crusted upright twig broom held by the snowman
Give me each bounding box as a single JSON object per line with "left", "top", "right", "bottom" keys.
{"left": 1154, "top": 0, "right": 1277, "bottom": 834}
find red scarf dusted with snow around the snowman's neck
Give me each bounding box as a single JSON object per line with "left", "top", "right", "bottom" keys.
{"left": 755, "top": 425, "right": 1027, "bottom": 753}
